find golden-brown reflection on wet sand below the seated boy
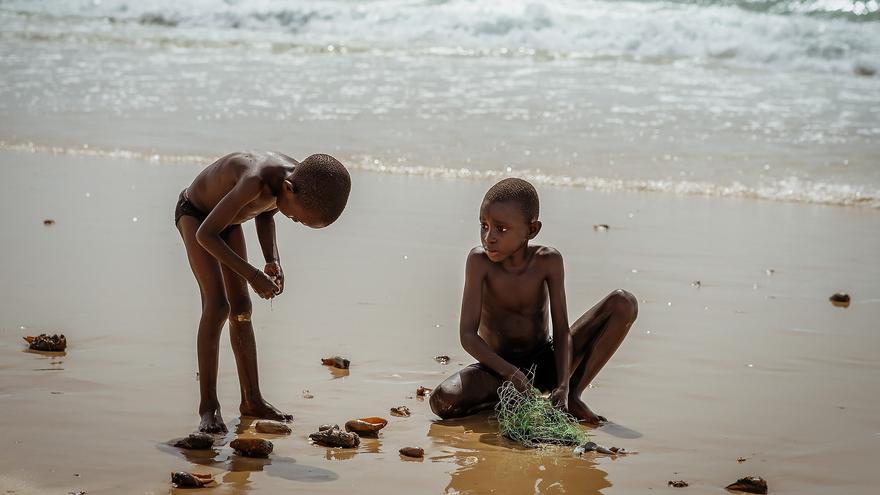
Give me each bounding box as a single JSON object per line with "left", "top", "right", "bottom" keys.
{"left": 428, "top": 413, "right": 611, "bottom": 495}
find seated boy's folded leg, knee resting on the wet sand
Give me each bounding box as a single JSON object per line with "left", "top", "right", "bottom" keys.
{"left": 430, "top": 364, "right": 503, "bottom": 419}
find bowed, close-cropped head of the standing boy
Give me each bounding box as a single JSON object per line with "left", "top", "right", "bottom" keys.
{"left": 293, "top": 154, "right": 351, "bottom": 225}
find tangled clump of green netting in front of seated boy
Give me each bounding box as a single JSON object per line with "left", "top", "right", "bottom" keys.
{"left": 495, "top": 373, "right": 588, "bottom": 447}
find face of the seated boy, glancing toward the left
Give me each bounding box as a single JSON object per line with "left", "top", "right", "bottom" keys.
{"left": 480, "top": 201, "right": 541, "bottom": 262}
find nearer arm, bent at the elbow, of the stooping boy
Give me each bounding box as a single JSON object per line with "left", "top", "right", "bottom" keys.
{"left": 196, "top": 177, "right": 274, "bottom": 297}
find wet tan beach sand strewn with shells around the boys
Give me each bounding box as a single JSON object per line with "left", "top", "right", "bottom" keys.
{"left": 0, "top": 152, "right": 880, "bottom": 495}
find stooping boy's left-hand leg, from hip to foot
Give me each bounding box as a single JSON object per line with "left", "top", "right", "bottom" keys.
{"left": 177, "top": 216, "right": 229, "bottom": 433}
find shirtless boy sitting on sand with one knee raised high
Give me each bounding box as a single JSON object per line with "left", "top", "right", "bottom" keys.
{"left": 430, "top": 179, "right": 638, "bottom": 424}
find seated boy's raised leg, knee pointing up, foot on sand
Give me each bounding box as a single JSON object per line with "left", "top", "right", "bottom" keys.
{"left": 568, "top": 290, "right": 639, "bottom": 423}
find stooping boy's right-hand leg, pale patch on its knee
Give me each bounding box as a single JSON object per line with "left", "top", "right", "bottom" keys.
{"left": 222, "top": 225, "right": 293, "bottom": 421}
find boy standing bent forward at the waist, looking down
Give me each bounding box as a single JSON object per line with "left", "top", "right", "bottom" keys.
{"left": 174, "top": 152, "right": 351, "bottom": 433}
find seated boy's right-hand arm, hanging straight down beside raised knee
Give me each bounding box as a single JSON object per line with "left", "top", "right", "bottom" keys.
{"left": 547, "top": 249, "right": 572, "bottom": 408}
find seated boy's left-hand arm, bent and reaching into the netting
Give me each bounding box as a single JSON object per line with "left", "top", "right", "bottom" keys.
{"left": 459, "top": 248, "right": 528, "bottom": 388}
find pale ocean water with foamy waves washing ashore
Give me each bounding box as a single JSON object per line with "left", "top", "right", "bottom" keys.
{"left": 0, "top": 0, "right": 880, "bottom": 208}
